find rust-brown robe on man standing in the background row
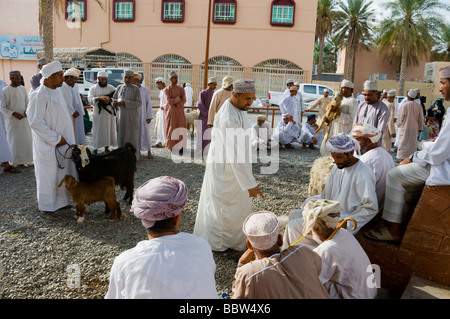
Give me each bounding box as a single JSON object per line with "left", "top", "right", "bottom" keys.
{"left": 163, "top": 85, "right": 187, "bottom": 150}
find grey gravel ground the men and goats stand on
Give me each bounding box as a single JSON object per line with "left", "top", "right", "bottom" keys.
{"left": 0, "top": 112, "right": 320, "bottom": 299}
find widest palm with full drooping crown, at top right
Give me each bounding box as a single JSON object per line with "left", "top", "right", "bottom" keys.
{"left": 377, "top": 0, "right": 449, "bottom": 95}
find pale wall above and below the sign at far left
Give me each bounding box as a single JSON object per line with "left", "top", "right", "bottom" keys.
{"left": 0, "top": 0, "right": 39, "bottom": 91}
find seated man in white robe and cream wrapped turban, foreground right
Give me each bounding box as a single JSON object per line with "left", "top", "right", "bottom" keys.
{"left": 303, "top": 199, "right": 377, "bottom": 299}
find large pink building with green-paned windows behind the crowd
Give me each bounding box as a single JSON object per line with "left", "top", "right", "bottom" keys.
{"left": 54, "top": 0, "right": 317, "bottom": 100}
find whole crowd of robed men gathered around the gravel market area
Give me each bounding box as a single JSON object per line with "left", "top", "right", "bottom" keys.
{"left": 0, "top": 61, "right": 450, "bottom": 299}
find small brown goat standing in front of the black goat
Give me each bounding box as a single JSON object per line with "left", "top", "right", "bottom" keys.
{"left": 58, "top": 175, "right": 122, "bottom": 223}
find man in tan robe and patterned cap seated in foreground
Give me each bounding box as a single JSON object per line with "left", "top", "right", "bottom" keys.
{"left": 232, "top": 212, "right": 329, "bottom": 299}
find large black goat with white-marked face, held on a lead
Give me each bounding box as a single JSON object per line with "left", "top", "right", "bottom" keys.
{"left": 71, "top": 143, "right": 136, "bottom": 204}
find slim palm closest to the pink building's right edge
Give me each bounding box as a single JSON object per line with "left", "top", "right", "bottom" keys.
{"left": 316, "top": 0, "right": 336, "bottom": 80}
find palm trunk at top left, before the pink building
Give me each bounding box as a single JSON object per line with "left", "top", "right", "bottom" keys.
{"left": 39, "top": 0, "right": 103, "bottom": 61}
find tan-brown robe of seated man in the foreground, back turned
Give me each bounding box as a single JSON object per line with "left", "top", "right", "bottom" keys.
{"left": 232, "top": 246, "right": 330, "bottom": 299}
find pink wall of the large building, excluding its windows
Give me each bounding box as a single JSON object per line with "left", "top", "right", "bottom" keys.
{"left": 54, "top": 0, "right": 317, "bottom": 99}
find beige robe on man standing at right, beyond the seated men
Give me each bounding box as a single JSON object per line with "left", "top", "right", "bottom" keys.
{"left": 397, "top": 101, "right": 423, "bottom": 160}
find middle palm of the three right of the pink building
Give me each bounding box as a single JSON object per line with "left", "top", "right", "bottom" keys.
{"left": 335, "top": 0, "right": 374, "bottom": 81}
